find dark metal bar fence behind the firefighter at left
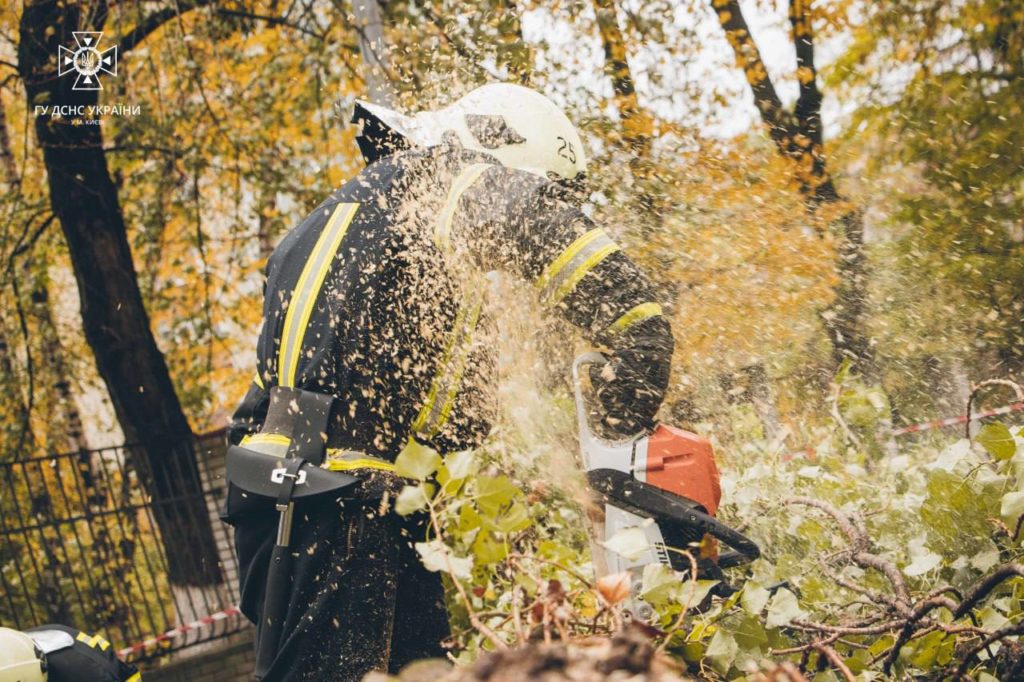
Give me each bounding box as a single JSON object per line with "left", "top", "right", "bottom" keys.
{"left": 0, "top": 433, "right": 247, "bottom": 659}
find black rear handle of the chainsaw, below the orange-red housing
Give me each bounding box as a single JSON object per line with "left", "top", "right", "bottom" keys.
{"left": 587, "top": 469, "right": 761, "bottom": 568}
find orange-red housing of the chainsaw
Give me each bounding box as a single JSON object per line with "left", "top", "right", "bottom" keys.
{"left": 641, "top": 424, "right": 722, "bottom": 516}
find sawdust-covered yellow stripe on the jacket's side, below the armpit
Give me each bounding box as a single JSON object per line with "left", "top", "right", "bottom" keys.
{"left": 413, "top": 279, "right": 486, "bottom": 438}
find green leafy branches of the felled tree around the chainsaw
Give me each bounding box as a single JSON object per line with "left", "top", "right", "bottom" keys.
{"left": 396, "top": 405, "right": 1024, "bottom": 680}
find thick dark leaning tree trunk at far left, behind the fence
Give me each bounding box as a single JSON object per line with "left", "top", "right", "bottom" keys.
{"left": 18, "top": 0, "right": 220, "bottom": 585}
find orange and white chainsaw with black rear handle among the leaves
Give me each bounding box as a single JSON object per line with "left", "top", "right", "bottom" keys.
{"left": 572, "top": 352, "right": 761, "bottom": 615}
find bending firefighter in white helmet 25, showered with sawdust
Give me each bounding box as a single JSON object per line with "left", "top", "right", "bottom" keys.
{"left": 224, "top": 84, "right": 673, "bottom": 680}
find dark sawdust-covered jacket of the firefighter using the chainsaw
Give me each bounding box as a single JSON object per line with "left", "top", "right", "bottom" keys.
{"left": 230, "top": 144, "right": 673, "bottom": 461}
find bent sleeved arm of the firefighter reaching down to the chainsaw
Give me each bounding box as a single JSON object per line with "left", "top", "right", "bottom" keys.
{"left": 457, "top": 167, "right": 674, "bottom": 434}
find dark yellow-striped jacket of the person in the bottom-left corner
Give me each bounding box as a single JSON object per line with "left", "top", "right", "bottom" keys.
{"left": 26, "top": 625, "right": 142, "bottom": 682}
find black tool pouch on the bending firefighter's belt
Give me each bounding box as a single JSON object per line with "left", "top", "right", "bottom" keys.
{"left": 221, "top": 389, "right": 359, "bottom": 524}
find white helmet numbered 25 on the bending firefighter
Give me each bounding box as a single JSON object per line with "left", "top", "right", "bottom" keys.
{"left": 353, "top": 83, "right": 587, "bottom": 181}
